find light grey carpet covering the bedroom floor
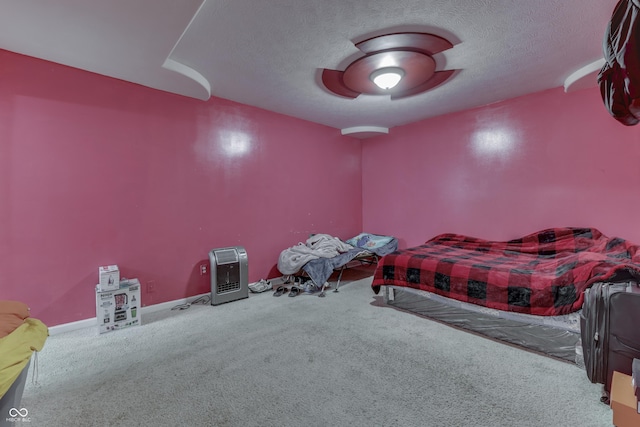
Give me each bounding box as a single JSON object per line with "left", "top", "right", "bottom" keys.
{"left": 22, "top": 271, "right": 611, "bottom": 427}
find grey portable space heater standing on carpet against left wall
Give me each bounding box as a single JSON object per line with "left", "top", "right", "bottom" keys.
{"left": 209, "top": 246, "right": 249, "bottom": 305}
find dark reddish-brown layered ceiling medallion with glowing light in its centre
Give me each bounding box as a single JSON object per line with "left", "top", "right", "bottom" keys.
{"left": 322, "top": 33, "right": 455, "bottom": 99}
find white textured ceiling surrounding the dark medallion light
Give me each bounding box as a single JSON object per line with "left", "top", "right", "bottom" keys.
{"left": 0, "top": 0, "right": 617, "bottom": 136}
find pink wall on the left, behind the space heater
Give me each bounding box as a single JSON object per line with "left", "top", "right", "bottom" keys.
{"left": 0, "top": 50, "right": 362, "bottom": 326}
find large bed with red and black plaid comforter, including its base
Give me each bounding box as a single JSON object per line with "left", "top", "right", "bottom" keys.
{"left": 371, "top": 227, "right": 640, "bottom": 364}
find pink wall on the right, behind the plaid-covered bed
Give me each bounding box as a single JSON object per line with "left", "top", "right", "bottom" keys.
{"left": 362, "top": 88, "right": 640, "bottom": 247}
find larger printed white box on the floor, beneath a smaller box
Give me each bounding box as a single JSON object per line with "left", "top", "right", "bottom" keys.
{"left": 96, "top": 279, "right": 142, "bottom": 334}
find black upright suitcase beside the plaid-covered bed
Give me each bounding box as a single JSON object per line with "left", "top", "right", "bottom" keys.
{"left": 580, "top": 282, "right": 640, "bottom": 403}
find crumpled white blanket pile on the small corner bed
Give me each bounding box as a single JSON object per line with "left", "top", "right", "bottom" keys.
{"left": 278, "top": 234, "right": 353, "bottom": 275}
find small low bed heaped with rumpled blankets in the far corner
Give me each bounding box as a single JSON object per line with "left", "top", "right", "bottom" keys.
{"left": 278, "top": 233, "right": 398, "bottom": 295}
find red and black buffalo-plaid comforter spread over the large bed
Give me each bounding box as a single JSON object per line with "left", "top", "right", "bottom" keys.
{"left": 371, "top": 228, "right": 640, "bottom": 316}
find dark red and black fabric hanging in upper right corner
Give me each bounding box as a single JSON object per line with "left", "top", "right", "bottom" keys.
{"left": 598, "top": 0, "right": 640, "bottom": 126}
